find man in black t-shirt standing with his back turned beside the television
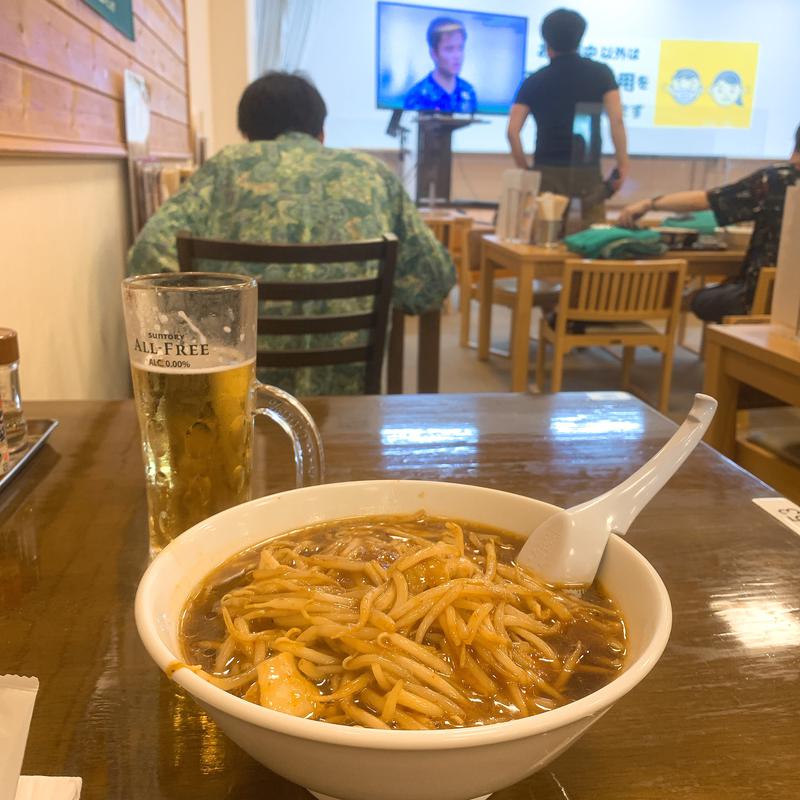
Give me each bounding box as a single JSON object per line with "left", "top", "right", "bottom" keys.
{"left": 508, "top": 8, "right": 628, "bottom": 225}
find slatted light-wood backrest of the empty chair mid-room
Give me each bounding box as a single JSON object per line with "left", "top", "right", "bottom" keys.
{"left": 557, "top": 258, "right": 686, "bottom": 332}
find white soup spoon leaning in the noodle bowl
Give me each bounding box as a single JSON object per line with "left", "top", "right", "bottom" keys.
{"left": 517, "top": 394, "right": 717, "bottom": 586}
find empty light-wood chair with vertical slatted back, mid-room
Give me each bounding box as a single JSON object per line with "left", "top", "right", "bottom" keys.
{"left": 536, "top": 259, "right": 686, "bottom": 412}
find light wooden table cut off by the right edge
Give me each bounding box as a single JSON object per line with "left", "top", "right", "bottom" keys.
{"left": 703, "top": 324, "right": 800, "bottom": 495}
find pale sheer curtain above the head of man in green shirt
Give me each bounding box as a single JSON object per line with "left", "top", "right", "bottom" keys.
{"left": 254, "top": 0, "right": 319, "bottom": 77}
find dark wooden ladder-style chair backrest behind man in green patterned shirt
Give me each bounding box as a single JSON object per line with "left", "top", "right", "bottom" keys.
{"left": 177, "top": 233, "right": 398, "bottom": 394}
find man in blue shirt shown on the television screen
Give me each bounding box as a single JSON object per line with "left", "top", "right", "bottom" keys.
{"left": 403, "top": 17, "right": 478, "bottom": 114}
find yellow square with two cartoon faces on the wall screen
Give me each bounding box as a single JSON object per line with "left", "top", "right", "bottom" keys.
{"left": 655, "top": 39, "right": 758, "bottom": 128}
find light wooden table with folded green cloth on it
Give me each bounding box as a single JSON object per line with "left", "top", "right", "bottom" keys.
{"left": 478, "top": 235, "right": 744, "bottom": 392}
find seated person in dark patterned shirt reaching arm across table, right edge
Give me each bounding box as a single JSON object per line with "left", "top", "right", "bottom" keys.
{"left": 619, "top": 127, "right": 800, "bottom": 322}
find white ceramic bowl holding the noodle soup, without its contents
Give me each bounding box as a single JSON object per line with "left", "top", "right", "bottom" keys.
{"left": 136, "top": 481, "right": 672, "bottom": 800}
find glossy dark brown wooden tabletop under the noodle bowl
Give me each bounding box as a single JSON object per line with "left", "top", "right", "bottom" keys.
{"left": 0, "top": 393, "right": 800, "bottom": 800}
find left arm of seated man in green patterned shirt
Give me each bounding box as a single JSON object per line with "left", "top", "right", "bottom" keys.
{"left": 127, "top": 169, "right": 213, "bottom": 275}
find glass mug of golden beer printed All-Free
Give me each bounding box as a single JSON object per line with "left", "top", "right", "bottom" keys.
{"left": 122, "top": 272, "right": 324, "bottom": 555}
